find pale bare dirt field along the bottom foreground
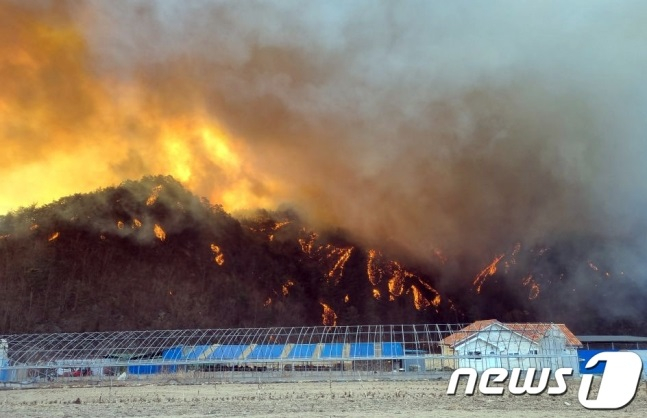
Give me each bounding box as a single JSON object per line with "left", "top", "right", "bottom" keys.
{"left": 0, "top": 380, "right": 647, "bottom": 418}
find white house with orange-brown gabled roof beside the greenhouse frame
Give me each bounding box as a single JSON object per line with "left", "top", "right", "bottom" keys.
{"left": 441, "top": 319, "right": 582, "bottom": 371}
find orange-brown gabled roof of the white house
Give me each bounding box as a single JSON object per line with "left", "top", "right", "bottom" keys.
{"left": 441, "top": 319, "right": 582, "bottom": 347}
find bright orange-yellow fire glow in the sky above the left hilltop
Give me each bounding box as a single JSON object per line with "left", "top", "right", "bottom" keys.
{"left": 0, "top": 6, "right": 278, "bottom": 214}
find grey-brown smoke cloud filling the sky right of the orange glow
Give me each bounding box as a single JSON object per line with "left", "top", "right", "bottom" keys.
{"left": 5, "top": 0, "right": 647, "bottom": 282}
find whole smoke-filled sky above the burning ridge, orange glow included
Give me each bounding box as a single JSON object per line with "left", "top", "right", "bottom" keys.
{"left": 0, "top": 0, "right": 647, "bottom": 284}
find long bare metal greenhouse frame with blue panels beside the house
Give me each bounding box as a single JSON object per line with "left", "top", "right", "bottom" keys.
{"left": 0, "top": 324, "right": 577, "bottom": 386}
